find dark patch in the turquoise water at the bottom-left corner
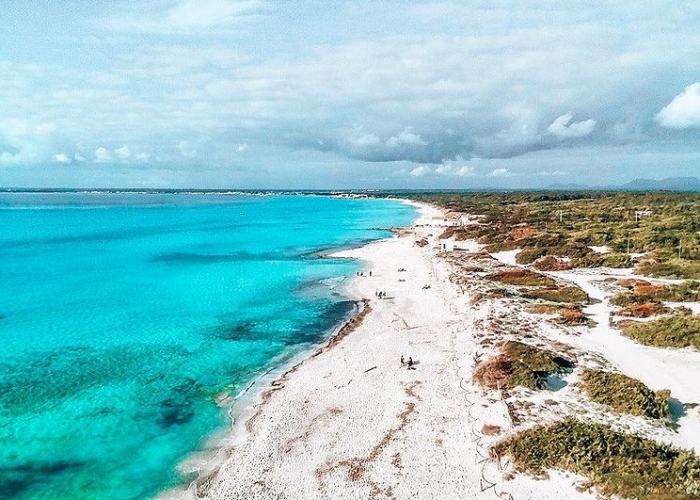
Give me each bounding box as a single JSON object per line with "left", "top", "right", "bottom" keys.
{"left": 0, "top": 460, "right": 86, "bottom": 500}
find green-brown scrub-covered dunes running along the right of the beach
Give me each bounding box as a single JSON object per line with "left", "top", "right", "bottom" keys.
{"left": 394, "top": 192, "right": 700, "bottom": 500}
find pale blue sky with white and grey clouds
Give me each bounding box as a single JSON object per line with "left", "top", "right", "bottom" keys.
{"left": 0, "top": 0, "right": 700, "bottom": 189}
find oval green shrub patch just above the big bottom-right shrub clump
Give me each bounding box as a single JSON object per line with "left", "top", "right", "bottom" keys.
{"left": 581, "top": 368, "right": 671, "bottom": 419}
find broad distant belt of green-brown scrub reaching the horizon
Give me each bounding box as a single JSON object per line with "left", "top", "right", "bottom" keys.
{"left": 397, "top": 191, "right": 700, "bottom": 278}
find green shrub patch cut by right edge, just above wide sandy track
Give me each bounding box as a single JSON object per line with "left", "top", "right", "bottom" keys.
{"left": 620, "top": 313, "right": 700, "bottom": 350}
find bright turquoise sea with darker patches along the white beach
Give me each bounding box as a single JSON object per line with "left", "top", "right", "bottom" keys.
{"left": 0, "top": 193, "right": 415, "bottom": 500}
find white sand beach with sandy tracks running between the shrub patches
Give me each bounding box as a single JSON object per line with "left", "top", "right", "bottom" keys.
{"left": 161, "top": 201, "right": 700, "bottom": 500}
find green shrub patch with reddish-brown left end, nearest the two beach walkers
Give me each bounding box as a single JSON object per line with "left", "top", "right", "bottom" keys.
{"left": 474, "top": 341, "right": 573, "bottom": 390}
